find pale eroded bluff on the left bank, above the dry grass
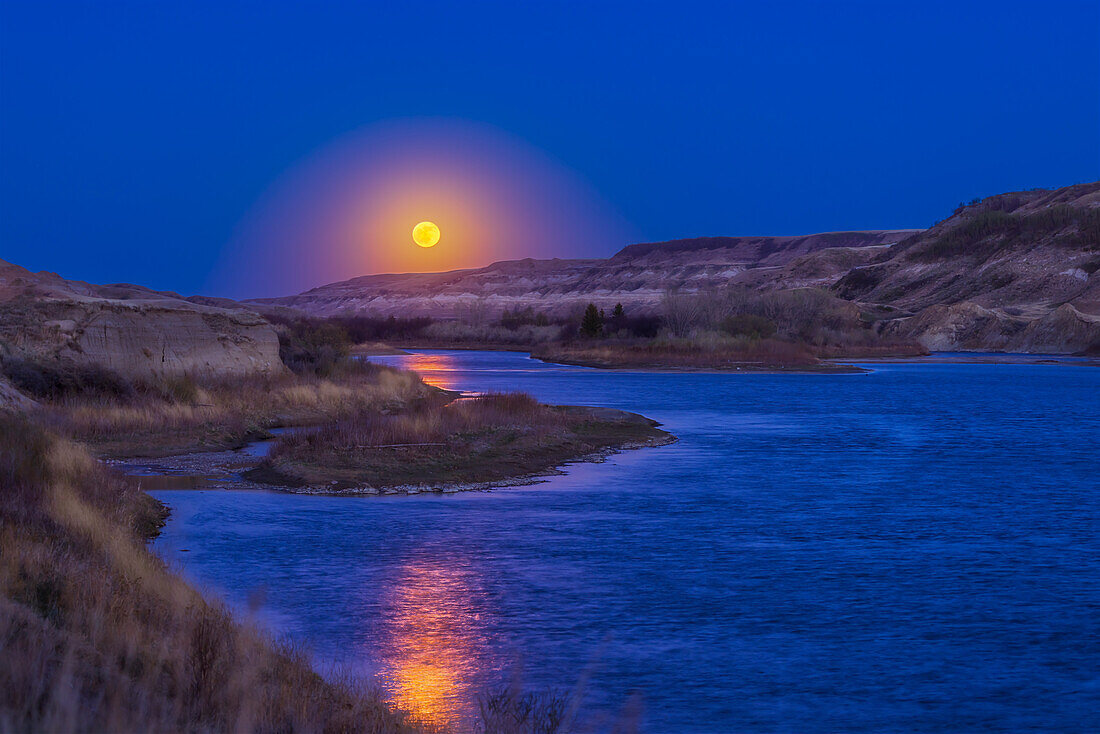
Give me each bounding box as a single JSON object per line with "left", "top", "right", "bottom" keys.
{"left": 0, "top": 261, "right": 284, "bottom": 377}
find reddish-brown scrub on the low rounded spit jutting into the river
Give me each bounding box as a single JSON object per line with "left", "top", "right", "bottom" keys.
{"left": 251, "top": 393, "right": 671, "bottom": 491}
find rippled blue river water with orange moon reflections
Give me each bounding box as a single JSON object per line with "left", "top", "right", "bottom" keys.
{"left": 154, "top": 351, "right": 1100, "bottom": 734}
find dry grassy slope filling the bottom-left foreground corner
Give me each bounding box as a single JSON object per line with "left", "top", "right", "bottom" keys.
{"left": 0, "top": 417, "right": 437, "bottom": 732}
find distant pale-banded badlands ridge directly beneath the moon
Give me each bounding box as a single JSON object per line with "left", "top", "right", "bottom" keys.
{"left": 248, "top": 230, "right": 917, "bottom": 318}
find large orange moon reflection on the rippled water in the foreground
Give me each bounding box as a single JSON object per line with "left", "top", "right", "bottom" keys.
{"left": 381, "top": 565, "right": 488, "bottom": 726}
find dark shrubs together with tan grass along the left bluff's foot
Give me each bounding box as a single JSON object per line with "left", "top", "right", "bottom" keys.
{"left": 2, "top": 346, "right": 442, "bottom": 457}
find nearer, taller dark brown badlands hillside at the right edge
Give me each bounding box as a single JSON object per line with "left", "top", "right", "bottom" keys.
{"left": 834, "top": 183, "right": 1100, "bottom": 352}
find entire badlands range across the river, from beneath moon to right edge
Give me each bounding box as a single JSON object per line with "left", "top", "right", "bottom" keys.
{"left": 253, "top": 183, "right": 1100, "bottom": 353}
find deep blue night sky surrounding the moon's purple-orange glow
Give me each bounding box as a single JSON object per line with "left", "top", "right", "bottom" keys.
{"left": 0, "top": 0, "right": 1100, "bottom": 296}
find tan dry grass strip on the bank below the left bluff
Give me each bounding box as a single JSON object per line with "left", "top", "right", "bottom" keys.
{"left": 45, "top": 362, "right": 440, "bottom": 456}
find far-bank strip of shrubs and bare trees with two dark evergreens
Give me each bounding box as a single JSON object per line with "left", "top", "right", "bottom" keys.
{"left": 292, "top": 288, "right": 927, "bottom": 371}
